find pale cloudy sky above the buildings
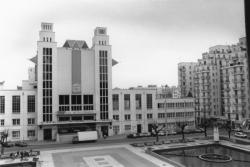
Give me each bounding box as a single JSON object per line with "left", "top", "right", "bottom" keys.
{"left": 0, "top": 0, "right": 245, "bottom": 89}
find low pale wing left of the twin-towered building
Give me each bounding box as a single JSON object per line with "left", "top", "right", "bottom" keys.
{"left": 0, "top": 90, "right": 38, "bottom": 140}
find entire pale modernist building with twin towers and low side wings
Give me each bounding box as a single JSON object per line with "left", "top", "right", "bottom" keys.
{"left": 0, "top": 23, "right": 195, "bottom": 141}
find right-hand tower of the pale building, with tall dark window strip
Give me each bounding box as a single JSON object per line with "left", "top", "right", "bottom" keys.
{"left": 92, "top": 27, "right": 112, "bottom": 134}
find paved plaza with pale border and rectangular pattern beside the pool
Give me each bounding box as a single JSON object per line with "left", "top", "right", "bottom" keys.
{"left": 40, "top": 145, "right": 173, "bottom": 167}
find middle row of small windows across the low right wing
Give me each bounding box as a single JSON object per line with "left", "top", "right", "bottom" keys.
{"left": 113, "top": 112, "right": 194, "bottom": 121}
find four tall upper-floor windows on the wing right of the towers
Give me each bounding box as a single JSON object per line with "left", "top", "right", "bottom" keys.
{"left": 112, "top": 94, "right": 153, "bottom": 110}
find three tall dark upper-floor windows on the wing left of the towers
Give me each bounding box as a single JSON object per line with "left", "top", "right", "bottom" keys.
{"left": 0, "top": 95, "right": 36, "bottom": 114}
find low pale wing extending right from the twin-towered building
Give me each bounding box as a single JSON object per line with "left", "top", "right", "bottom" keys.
{"left": 112, "top": 87, "right": 195, "bottom": 134}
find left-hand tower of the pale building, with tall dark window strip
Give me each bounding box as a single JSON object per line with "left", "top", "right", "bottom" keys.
{"left": 37, "top": 23, "right": 57, "bottom": 140}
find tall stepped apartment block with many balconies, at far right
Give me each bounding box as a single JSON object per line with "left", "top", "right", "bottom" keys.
{"left": 179, "top": 38, "right": 250, "bottom": 125}
